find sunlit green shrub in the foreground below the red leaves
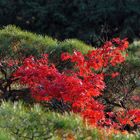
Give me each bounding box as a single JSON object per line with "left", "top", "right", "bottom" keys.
{"left": 0, "top": 102, "right": 139, "bottom": 140}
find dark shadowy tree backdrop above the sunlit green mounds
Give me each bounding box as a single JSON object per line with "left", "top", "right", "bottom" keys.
{"left": 0, "top": 0, "right": 140, "bottom": 44}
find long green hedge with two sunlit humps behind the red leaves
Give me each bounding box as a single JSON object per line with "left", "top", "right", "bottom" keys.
{"left": 0, "top": 25, "right": 92, "bottom": 61}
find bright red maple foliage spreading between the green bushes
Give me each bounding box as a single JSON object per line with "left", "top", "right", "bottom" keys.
{"left": 14, "top": 38, "right": 140, "bottom": 130}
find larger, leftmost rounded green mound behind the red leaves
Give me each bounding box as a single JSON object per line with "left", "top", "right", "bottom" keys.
{"left": 0, "top": 26, "right": 58, "bottom": 58}
